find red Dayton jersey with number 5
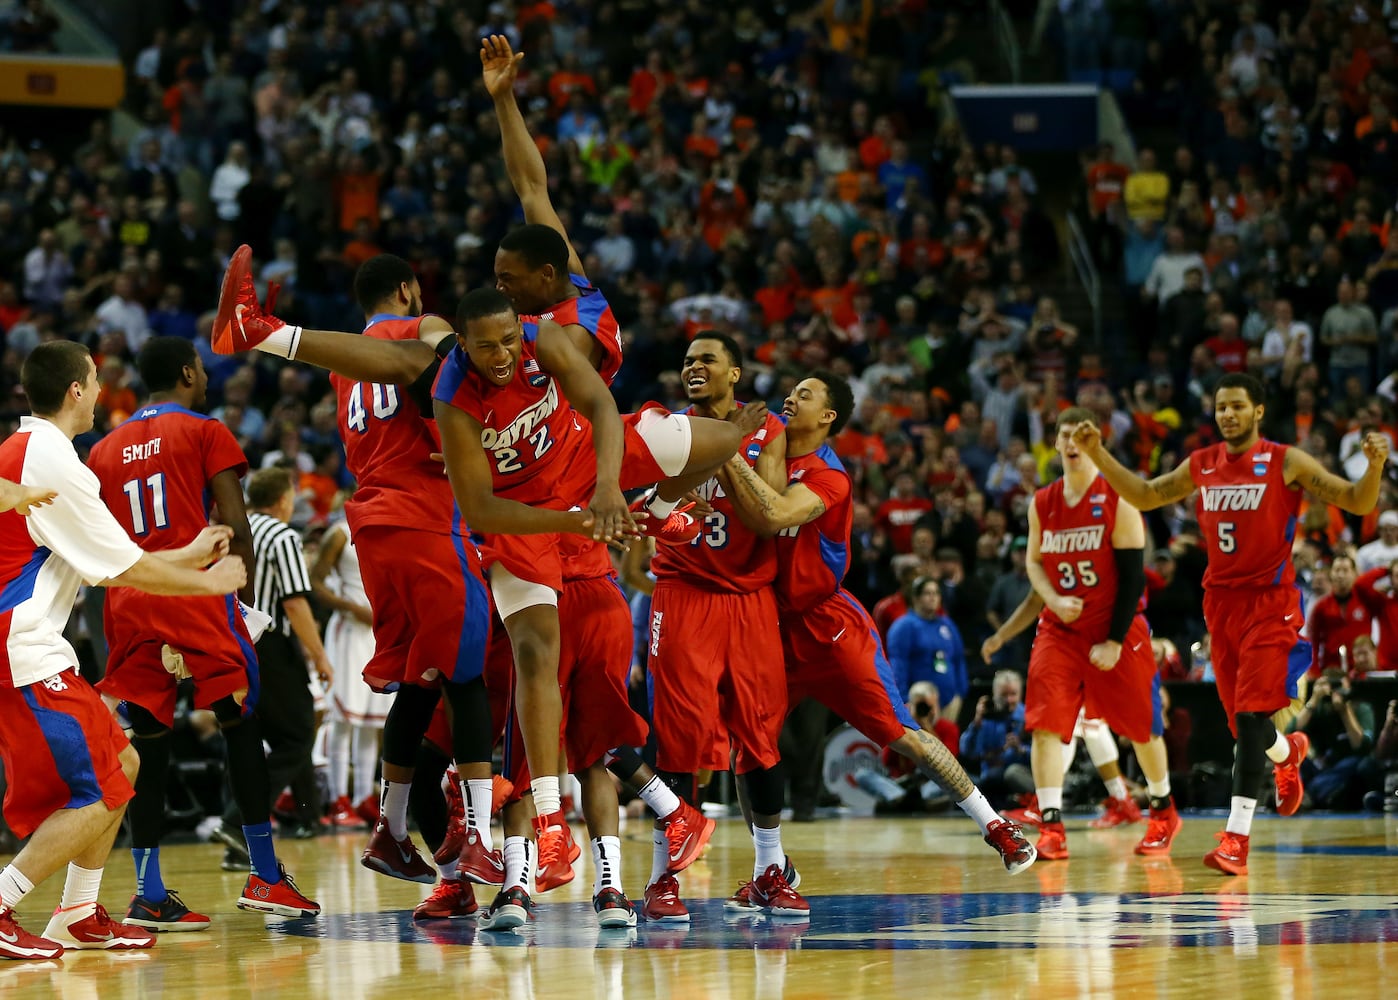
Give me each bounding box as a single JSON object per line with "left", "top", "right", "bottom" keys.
{"left": 1190, "top": 441, "right": 1302, "bottom": 590}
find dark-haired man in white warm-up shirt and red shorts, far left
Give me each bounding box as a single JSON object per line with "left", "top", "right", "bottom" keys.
{"left": 0, "top": 340, "right": 247, "bottom": 959}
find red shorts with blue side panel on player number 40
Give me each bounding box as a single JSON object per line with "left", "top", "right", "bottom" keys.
{"left": 354, "top": 524, "right": 491, "bottom": 691}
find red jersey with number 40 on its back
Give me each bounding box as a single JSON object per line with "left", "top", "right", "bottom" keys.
{"left": 330, "top": 315, "right": 456, "bottom": 534}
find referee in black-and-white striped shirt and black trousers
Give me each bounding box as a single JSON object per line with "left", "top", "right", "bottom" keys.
{"left": 224, "top": 469, "right": 331, "bottom": 838}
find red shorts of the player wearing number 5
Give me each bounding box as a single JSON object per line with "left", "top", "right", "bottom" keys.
{"left": 1204, "top": 587, "right": 1304, "bottom": 726}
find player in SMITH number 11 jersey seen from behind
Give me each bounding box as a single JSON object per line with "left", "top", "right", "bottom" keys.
{"left": 88, "top": 337, "right": 320, "bottom": 930}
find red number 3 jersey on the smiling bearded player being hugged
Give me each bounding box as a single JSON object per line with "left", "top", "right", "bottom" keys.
{"left": 650, "top": 404, "right": 786, "bottom": 594}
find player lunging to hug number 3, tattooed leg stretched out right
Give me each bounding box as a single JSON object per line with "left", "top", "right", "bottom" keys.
{"left": 719, "top": 372, "right": 1035, "bottom": 878}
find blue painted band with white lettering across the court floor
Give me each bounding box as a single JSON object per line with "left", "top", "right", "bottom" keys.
{"left": 270, "top": 891, "right": 1398, "bottom": 954}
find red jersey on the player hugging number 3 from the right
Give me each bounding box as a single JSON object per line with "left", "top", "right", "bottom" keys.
{"left": 777, "top": 442, "right": 854, "bottom": 611}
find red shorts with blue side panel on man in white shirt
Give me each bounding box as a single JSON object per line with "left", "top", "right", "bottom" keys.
{"left": 0, "top": 669, "right": 136, "bottom": 839}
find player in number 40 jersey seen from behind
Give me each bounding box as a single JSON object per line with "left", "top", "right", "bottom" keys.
{"left": 214, "top": 248, "right": 500, "bottom": 909}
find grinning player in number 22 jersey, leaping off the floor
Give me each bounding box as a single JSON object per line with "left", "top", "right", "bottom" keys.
{"left": 433, "top": 288, "right": 741, "bottom": 885}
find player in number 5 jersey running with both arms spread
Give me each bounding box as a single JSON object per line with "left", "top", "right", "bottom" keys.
{"left": 1074, "top": 373, "right": 1388, "bottom": 876}
